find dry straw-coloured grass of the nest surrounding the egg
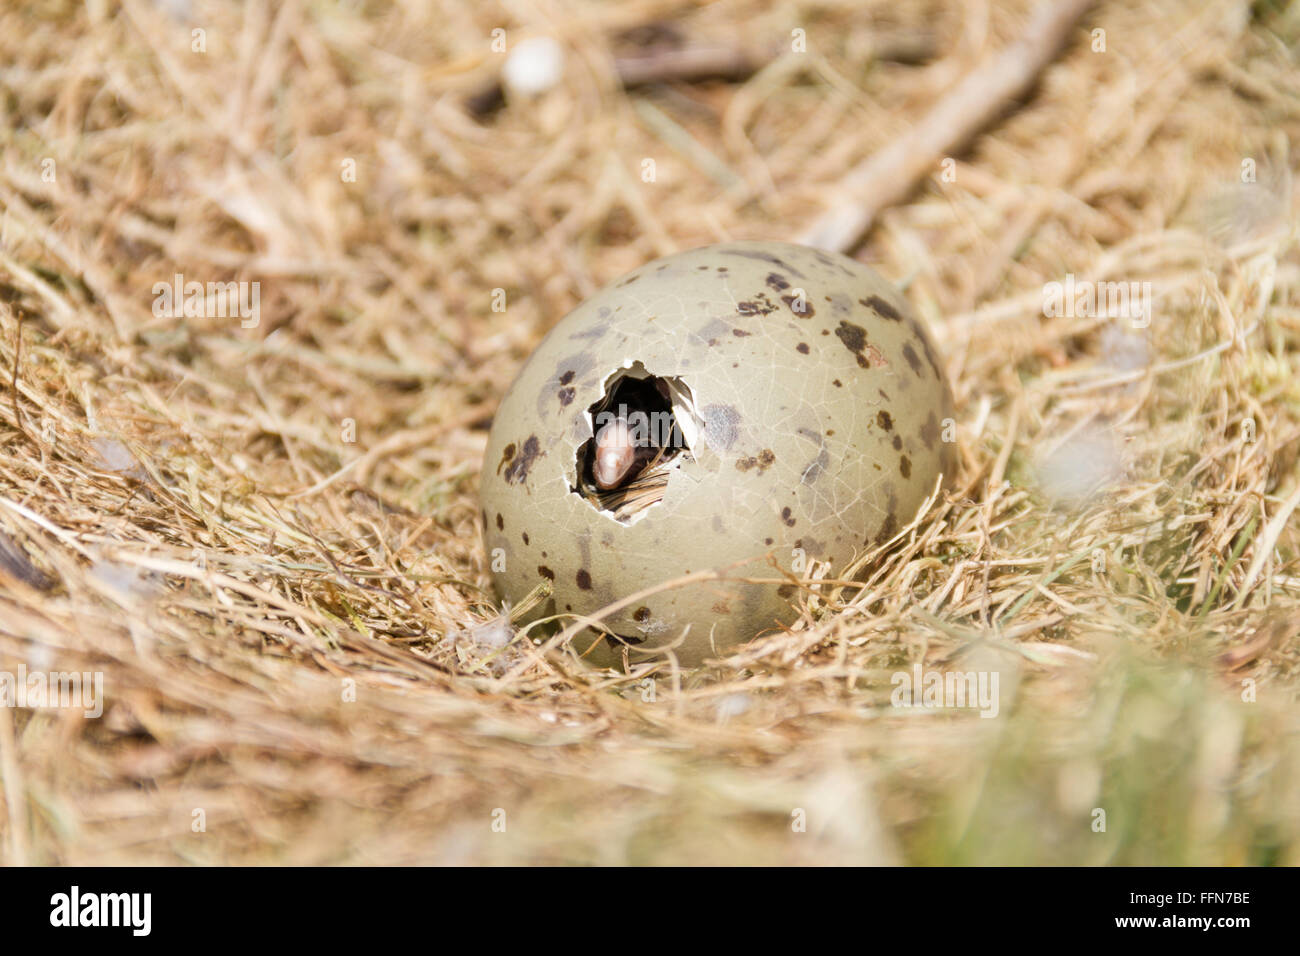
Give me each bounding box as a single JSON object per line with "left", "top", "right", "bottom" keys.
{"left": 0, "top": 0, "right": 1300, "bottom": 865}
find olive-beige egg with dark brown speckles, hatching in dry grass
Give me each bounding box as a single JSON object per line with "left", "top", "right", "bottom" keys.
{"left": 482, "top": 242, "right": 956, "bottom": 666}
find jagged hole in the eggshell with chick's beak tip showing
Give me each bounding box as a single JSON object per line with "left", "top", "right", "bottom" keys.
{"left": 571, "top": 362, "right": 699, "bottom": 524}
